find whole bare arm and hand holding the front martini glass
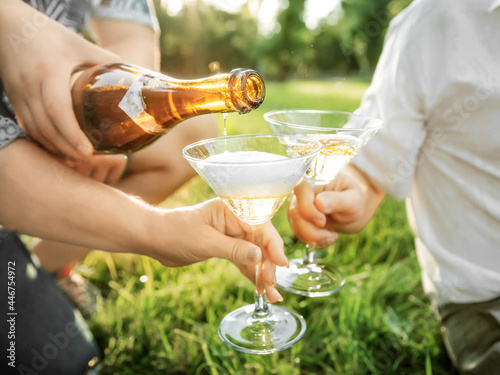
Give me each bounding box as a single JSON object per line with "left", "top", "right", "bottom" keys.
{"left": 0, "top": 139, "right": 287, "bottom": 301}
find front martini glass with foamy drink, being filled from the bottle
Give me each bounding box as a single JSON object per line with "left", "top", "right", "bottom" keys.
{"left": 182, "top": 135, "right": 322, "bottom": 354}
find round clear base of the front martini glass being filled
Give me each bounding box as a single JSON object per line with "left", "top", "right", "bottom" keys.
{"left": 218, "top": 305, "right": 306, "bottom": 354}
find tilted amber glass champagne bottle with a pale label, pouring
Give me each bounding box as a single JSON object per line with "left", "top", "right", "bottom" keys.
{"left": 72, "top": 63, "right": 265, "bottom": 154}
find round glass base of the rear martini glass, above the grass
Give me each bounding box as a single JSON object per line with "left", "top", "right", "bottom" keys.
{"left": 276, "top": 259, "right": 345, "bottom": 297}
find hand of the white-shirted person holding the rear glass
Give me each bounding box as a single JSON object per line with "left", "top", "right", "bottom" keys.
{"left": 288, "top": 172, "right": 366, "bottom": 247}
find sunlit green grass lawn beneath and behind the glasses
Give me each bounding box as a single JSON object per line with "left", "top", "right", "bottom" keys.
{"left": 85, "top": 79, "right": 453, "bottom": 375}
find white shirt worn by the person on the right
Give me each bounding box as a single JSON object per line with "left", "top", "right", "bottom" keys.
{"left": 353, "top": 0, "right": 500, "bottom": 304}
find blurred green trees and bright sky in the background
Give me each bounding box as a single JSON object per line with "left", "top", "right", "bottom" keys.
{"left": 155, "top": 0, "right": 411, "bottom": 80}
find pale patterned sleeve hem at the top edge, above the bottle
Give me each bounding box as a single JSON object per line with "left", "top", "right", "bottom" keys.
{"left": 89, "top": 0, "right": 158, "bottom": 30}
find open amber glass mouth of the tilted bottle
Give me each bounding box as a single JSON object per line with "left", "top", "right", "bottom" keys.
{"left": 229, "top": 69, "right": 266, "bottom": 114}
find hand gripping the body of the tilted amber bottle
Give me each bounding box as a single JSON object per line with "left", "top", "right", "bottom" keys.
{"left": 0, "top": 0, "right": 120, "bottom": 160}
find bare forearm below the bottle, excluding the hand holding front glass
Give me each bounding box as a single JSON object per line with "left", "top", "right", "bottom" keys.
{"left": 0, "top": 139, "right": 153, "bottom": 258}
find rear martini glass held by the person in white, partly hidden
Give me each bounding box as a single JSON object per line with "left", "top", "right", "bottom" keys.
{"left": 264, "top": 110, "right": 382, "bottom": 297}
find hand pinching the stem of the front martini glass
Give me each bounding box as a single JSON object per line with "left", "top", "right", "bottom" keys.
{"left": 148, "top": 198, "right": 288, "bottom": 302}
